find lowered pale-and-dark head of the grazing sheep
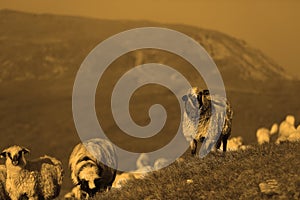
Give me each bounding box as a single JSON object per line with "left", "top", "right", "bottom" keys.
{"left": 78, "top": 165, "right": 101, "bottom": 196}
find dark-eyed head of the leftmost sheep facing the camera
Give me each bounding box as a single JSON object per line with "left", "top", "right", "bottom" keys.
{"left": 0, "top": 145, "right": 29, "bottom": 166}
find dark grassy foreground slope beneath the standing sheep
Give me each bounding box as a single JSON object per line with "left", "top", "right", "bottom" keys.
{"left": 94, "top": 143, "right": 300, "bottom": 200}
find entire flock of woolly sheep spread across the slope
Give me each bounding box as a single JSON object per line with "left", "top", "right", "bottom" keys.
{"left": 0, "top": 88, "right": 300, "bottom": 200}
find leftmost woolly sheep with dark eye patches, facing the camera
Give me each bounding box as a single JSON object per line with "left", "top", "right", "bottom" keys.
{"left": 0, "top": 145, "right": 63, "bottom": 200}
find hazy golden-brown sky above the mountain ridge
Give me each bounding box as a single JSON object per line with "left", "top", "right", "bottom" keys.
{"left": 0, "top": 0, "right": 300, "bottom": 77}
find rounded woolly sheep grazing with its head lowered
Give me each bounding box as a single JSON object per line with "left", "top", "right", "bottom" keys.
{"left": 69, "top": 138, "right": 117, "bottom": 197}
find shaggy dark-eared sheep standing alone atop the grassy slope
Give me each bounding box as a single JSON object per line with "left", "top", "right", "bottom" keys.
{"left": 182, "top": 87, "right": 233, "bottom": 157}
